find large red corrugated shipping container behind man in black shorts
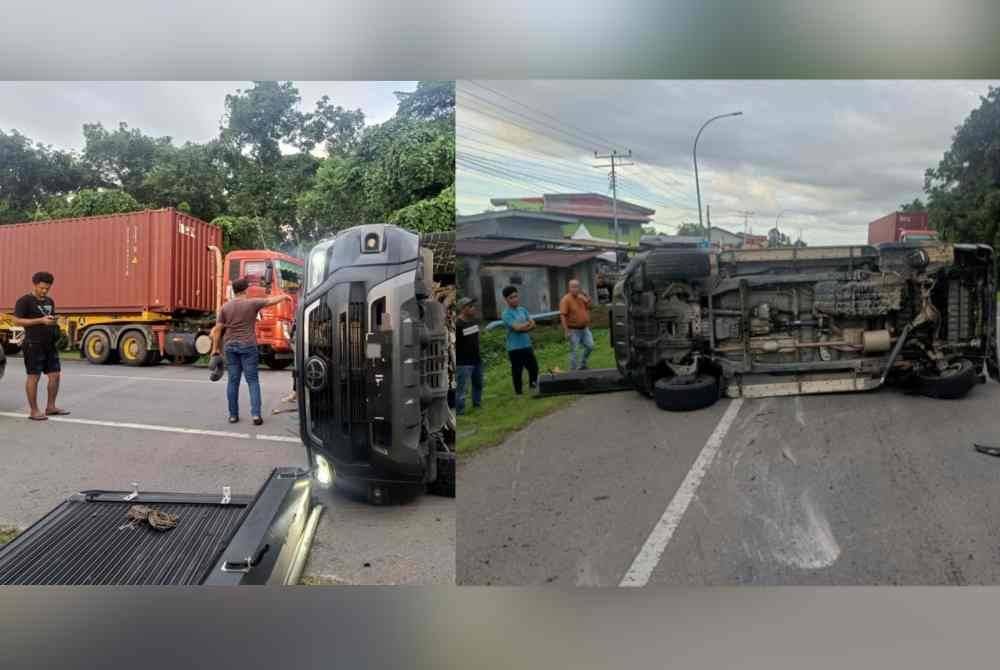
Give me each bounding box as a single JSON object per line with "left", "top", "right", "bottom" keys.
{"left": 0, "top": 209, "right": 222, "bottom": 314}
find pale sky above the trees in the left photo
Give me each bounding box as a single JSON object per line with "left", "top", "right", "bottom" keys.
{"left": 0, "top": 81, "right": 416, "bottom": 150}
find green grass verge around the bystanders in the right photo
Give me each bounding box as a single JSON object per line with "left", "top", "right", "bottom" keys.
{"left": 458, "top": 314, "right": 615, "bottom": 455}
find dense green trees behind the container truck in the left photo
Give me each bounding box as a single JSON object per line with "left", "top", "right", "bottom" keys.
{"left": 0, "top": 81, "right": 455, "bottom": 250}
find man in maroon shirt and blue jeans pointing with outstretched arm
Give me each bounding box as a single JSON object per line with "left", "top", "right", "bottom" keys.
{"left": 212, "top": 277, "right": 292, "bottom": 426}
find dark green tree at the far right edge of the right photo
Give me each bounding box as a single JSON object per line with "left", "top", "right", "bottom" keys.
{"left": 924, "top": 86, "right": 1000, "bottom": 246}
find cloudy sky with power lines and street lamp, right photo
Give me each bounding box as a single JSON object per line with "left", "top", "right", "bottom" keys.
{"left": 457, "top": 80, "right": 996, "bottom": 245}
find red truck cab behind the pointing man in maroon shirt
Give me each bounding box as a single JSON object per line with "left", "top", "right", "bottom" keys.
{"left": 225, "top": 250, "right": 305, "bottom": 370}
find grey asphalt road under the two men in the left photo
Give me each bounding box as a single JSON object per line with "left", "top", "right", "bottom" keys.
{"left": 0, "top": 358, "right": 455, "bottom": 584}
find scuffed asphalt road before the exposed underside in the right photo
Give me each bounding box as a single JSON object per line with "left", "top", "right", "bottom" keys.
{"left": 456, "top": 382, "right": 1000, "bottom": 586}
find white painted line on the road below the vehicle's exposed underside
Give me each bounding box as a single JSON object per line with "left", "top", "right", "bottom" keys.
{"left": 619, "top": 398, "right": 743, "bottom": 586}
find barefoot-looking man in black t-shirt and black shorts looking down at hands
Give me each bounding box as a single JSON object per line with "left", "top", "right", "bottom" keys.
{"left": 14, "top": 272, "right": 69, "bottom": 421}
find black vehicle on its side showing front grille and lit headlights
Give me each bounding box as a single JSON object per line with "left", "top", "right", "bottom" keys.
{"left": 295, "top": 224, "right": 455, "bottom": 503}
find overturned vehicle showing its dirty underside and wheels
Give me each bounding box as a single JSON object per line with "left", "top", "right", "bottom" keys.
{"left": 611, "top": 242, "right": 997, "bottom": 410}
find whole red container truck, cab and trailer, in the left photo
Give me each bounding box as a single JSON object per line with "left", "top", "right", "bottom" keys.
{"left": 0, "top": 209, "right": 304, "bottom": 369}
